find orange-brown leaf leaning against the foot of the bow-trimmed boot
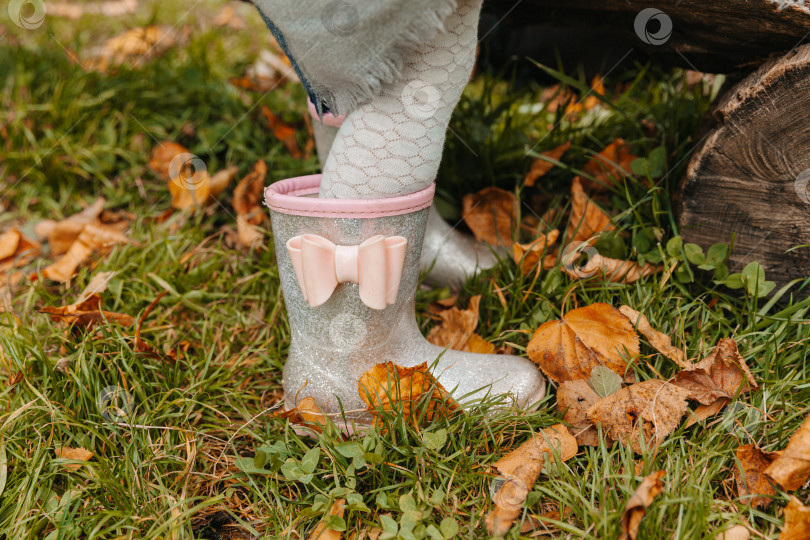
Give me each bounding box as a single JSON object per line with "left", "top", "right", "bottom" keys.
{"left": 357, "top": 362, "right": 459, "bottom": 424}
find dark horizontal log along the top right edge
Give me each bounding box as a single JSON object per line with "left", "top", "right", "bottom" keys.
{"left": 484, "top": 0, "right": 810, "bottom": 73}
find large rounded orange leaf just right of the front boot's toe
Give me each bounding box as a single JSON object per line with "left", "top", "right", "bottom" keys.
{"left": 526, "top": 303, "right": 639, "bottom": 383}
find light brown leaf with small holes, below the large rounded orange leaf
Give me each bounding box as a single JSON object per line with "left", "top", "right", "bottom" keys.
{"left": 587, "top": 379, "right": 688, "bottom": 453}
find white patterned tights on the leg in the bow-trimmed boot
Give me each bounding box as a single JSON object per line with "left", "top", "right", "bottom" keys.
{"left": 320, "top": 0, "right": 482, "bottom": 199}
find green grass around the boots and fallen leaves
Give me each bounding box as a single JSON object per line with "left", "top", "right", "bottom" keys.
{"left": 0, "top": 2, "right": 810, "bottom": 540}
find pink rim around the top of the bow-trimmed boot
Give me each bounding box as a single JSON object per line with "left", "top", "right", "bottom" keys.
{"left": 264, "top": 174, "right": 436, "bottom": 218}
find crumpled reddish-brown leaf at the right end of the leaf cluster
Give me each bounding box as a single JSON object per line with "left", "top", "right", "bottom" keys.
{"left": 672, "top": 338, "right": 757, "bottom": 405}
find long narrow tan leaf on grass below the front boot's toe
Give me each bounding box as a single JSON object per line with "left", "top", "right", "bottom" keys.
{"left": 487, "top": 424, "right": 577, "bottom": 536}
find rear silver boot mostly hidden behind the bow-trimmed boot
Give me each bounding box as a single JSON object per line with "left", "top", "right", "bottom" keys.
{"left": 309, "top": 102, "right": 498, "bottom": 289}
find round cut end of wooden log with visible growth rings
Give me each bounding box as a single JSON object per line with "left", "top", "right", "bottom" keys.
{"left": 675, "top": 45, "right": 810, "bottom": 284}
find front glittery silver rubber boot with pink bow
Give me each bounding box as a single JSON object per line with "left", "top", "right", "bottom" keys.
{"left": 265, "top": 175, "right": 546, "bottom": 422}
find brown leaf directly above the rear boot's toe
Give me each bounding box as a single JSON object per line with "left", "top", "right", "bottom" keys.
{"left": 462, "top": 187, "right": 518, "bottom": 246}
